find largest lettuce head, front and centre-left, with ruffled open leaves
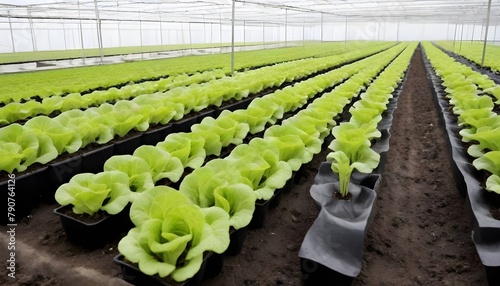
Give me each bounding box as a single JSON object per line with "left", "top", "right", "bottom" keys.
{"left": 118, "top": 186, "right": 229, "bottom": 282}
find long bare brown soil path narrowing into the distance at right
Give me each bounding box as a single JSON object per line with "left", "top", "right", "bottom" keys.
{"left": 354, "top": 46, "right": 487, "bottom": 286}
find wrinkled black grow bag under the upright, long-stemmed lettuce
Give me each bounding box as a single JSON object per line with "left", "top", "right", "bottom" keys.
{"left": 299, "top": 166, "right": 381, "bottom": 285}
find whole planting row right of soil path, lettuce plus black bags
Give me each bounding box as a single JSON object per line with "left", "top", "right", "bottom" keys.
{"left": 423, "top": 43, "right": 500, "bottom": 285}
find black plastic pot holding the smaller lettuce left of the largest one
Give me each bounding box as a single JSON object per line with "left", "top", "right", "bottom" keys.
{"left": 54, "top": 204, "right": 133, "bottom": 249}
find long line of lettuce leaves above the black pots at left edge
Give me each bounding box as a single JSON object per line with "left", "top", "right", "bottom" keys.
{"left": 0, "top": 42, "right": 394, "bottom": 173}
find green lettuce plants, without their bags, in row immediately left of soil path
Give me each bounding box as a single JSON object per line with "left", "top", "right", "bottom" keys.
{"left": 327, "top": 43, "right": 417, "bottom": 197}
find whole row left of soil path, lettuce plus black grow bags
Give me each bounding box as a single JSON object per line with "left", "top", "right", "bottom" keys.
{"left": 299, "top": 43, "right": 416, "bottom": 285}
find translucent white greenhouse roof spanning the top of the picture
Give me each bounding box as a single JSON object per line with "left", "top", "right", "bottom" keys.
{"left": 0, "top": 0, "right": 500, "bottom": 25}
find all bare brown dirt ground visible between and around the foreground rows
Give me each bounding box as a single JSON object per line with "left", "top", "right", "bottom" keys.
{"left": 0, "top": 46, "right": 487, "bottom": 286}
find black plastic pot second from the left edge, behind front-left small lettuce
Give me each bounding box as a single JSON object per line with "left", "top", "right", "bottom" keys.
{"left": 42, "top": 155, "right": 83, "bottom": 204}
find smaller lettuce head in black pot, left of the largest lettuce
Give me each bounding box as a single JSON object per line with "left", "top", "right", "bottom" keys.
{"left": 55, "top": 171, "right": 130, "bottom": 215}
